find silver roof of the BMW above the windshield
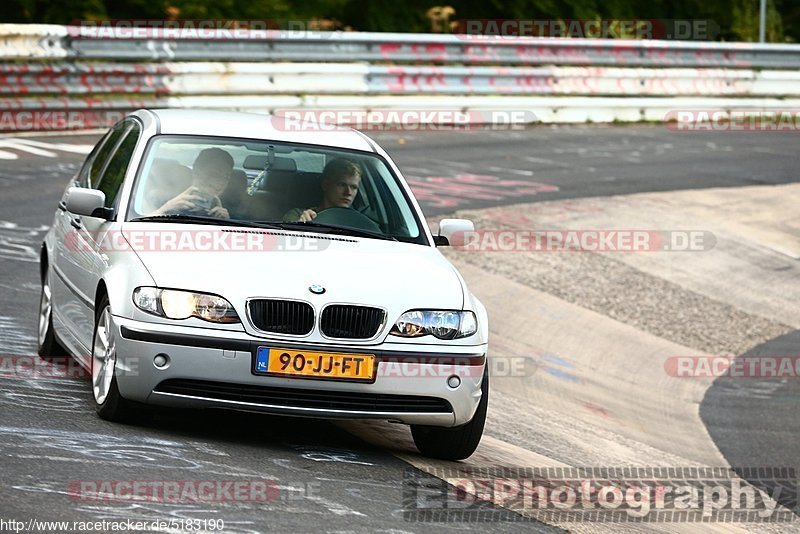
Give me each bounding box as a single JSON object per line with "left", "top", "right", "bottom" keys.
{"left": 141, "top": 109, "right": 375, "bottom": 152}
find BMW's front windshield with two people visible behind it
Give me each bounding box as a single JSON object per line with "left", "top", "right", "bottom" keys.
{"left": 127, "top": 136, "right": 427, "bottom": 244}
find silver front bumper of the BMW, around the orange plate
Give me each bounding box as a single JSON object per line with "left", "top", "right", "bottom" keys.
{"left": 114, "top": 317, "right": 487, "bottom": 427}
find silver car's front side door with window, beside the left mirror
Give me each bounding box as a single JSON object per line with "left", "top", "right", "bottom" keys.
{"left": 54, "top": 118, "right": 141, "bottom": 357}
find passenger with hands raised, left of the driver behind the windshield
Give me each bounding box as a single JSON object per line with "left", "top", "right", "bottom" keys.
{"left": 151, "top": 148, "right": 233, "bottom": 219}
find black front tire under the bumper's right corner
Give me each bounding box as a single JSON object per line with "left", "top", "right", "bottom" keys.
{"left": 411, "top": 371, "right": 489, "bottom": 460}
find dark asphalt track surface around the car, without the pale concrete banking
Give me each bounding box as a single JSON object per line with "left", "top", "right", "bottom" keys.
{"left": 0, "top": 125, "right": 800, "bottom": 533}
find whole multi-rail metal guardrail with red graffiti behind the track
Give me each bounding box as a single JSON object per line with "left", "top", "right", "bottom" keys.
{"left": 0, "top": 24, "right": 800, "bottom": 131}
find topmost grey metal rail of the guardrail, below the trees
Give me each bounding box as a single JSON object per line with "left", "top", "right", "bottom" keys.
{"left": 65, "top": 27, "right": 800, "bottom": 69}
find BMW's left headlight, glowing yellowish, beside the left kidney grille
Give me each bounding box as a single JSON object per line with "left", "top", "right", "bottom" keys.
{"left": 133, "top": 287, "right": 239, "bottom": 323}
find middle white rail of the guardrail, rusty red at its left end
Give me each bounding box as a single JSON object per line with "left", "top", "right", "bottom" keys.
{"left": 0, "top": 62, "right": 800, "bottom": 97}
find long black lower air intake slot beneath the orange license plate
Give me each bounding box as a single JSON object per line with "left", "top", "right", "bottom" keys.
{"left": 155, "top": 378, "right": 453, "bottom": 413}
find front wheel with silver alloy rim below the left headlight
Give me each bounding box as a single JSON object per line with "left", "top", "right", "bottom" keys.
{"left": 92, "top": 296, "right": 133, "bottom": 422}
